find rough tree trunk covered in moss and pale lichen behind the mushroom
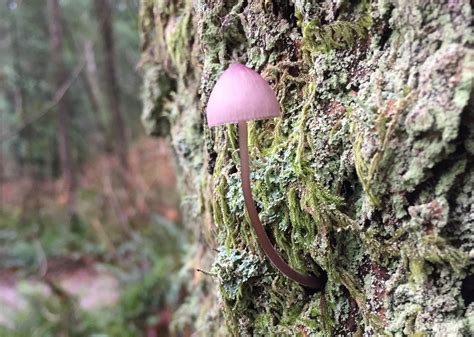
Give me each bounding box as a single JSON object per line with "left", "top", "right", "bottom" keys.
{"left": 140, "top": 0, "right": 474, "bottom": 336}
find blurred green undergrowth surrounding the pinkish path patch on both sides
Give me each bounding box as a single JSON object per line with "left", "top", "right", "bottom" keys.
{"left": 0, "top": 206, "right": 183, "bottom": 337}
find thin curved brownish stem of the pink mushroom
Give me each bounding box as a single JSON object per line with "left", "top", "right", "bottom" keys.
{"left": 239, "top": 122, "right": 323, "bottom": 289}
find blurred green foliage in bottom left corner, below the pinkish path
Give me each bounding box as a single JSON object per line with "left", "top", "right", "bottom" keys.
{"left": 0, "top": 263, "right": 170, "bottom": 337}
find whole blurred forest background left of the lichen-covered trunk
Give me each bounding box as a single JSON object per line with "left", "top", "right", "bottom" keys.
{"left": 0, "top": 0, "right": 186, "bottom": 337}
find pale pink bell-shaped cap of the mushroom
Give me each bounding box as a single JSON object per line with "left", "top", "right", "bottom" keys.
{"left": 206, "top": 63, "right": 280, "bottom": 127}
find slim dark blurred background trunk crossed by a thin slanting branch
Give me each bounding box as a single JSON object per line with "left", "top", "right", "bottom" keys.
{"left": 48, "top": 0, "right": 76, "bottom": 217}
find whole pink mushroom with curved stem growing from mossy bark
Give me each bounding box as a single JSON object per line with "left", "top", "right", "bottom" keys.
{"left": 206, "top": 63, "right": 323, "bottom": 289}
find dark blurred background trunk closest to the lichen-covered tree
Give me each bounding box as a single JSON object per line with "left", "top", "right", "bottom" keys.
{"left": 95, "top": 0, "right": 128, "bottom": 169}
